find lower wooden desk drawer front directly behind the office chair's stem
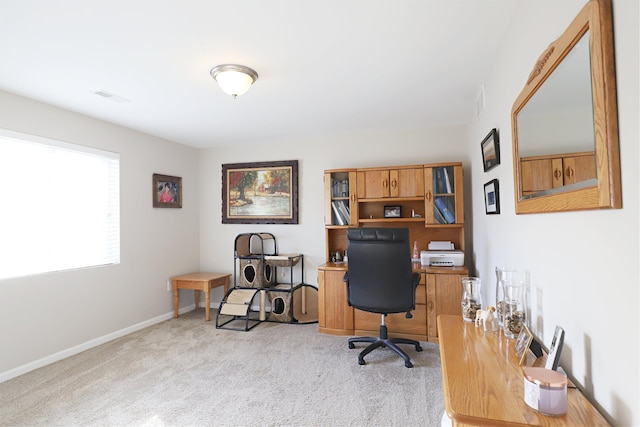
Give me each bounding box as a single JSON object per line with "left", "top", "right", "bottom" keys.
{"left": 353, "top": 304, "right": 427, "bottom": 335}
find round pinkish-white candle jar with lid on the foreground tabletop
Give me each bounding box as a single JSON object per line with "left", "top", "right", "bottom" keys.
{"left": 524, "top": 367, "right": 567, "bottom": 415}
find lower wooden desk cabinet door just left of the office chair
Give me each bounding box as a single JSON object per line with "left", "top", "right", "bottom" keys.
{"left": 318, "top": 270, "right": 353, "bottom": 335}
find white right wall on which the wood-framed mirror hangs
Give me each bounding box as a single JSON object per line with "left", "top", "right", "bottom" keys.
{"left": 468, "top": 0, "right": 640, "bottom": 425}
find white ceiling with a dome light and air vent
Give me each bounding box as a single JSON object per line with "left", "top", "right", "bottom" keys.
{"left": 0, "top": 0, "right": 518, "bottom": 147}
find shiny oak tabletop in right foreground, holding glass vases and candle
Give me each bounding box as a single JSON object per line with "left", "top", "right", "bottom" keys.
{"left": 438, "top": 315, "right": 609, "bottom": 426}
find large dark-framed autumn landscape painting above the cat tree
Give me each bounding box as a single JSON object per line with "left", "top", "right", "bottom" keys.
{"left": 222, "top": 160, "right": 298, "bottom": 224}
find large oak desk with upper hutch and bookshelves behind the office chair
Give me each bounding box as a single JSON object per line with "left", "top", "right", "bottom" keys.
{"left": 318, "top": 162, "right": 468, "bottom": 342}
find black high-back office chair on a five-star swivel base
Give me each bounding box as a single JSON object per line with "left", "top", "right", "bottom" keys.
{"left": 344, "top": 227, "right": 422, "bottom": 368}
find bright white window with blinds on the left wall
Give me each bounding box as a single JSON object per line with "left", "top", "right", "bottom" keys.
{"left": 0, "top": 129, "right": 120, "bottom": 279}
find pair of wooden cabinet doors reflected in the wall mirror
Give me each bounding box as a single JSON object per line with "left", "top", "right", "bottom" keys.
{"left": 520, "top": 151, "right": 596, "bottom": 196}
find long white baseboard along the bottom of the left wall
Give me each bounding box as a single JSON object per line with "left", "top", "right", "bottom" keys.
{"left": 0, "top": 304, "right": 196, "bottom": 383}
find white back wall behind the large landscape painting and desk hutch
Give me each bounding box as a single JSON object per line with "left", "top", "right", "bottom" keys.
{"left": 200, "top": 126, "right": 467, "bottom": 302}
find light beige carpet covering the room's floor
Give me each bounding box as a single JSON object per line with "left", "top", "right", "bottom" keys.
{"left": 0, "top": 309, "right": 444, "bottom": 426}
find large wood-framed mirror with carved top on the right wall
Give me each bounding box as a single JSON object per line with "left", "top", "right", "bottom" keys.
{"left": 511, "top": 0, "right": 622, "bottom": 214}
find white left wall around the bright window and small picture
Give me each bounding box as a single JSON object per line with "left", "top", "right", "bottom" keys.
{"left": 0, "top": 91, "right": 200, "bottom": 381}
